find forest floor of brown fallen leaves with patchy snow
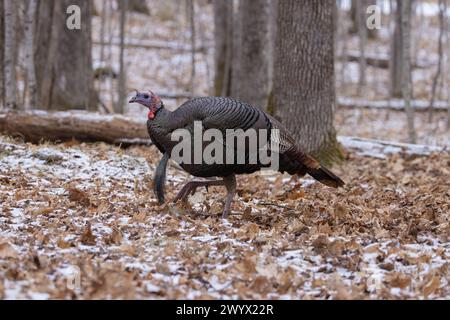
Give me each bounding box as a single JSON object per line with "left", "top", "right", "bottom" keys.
{"left": 0, "top": 137, "right": 450, "bottom": 299}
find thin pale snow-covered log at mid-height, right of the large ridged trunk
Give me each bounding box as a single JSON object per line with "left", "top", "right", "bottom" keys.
{"left": 337, "top": 97, "right": 448, "bottom": 111}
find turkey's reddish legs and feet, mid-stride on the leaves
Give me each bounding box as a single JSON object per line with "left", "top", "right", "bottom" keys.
{"left": 173, "top": 175, "right": 236, "bottom": 218}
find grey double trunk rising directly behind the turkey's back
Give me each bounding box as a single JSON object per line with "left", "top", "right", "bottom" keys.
{"left": 213, "top": 0, "right": 277, "bottom": 109}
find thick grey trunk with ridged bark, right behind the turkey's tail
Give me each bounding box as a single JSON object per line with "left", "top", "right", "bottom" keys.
{"left": 274, "top": 0, "right": 341, "bottom": 162}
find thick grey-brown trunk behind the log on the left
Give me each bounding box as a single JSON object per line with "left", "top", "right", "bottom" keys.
{"left": 35, "top": 0, "right": 97, "bottom": 110}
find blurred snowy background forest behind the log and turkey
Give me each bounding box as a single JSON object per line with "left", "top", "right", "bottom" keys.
{"left": 0, "top": 0, "right": 450, "bottom": 145}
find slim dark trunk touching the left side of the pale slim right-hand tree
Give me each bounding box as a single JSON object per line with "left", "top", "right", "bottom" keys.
{"left": 390, "top": 0, "right": 403, "bottom": 98}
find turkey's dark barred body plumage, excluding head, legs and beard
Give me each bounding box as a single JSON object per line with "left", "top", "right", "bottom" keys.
{"left": 147, "top": 97, "right": 343, "bottom": 186}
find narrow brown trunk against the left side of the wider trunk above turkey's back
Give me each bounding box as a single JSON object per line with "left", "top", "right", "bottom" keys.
{"left": 213, "top": 0, "right": 233, "bottom": 96}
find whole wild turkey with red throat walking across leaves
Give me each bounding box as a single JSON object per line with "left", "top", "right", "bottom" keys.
{"left": 130, "top": 91, "right": 344, "bottom": 218}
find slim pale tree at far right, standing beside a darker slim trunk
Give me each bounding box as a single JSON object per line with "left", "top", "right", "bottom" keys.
{"left": 397, "top": 0, "right": 416, "bottom": 143}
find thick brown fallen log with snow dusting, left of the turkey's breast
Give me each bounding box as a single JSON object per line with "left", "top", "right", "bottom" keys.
{"left": 0, "top": 110, "right": 149, "bottom": 144}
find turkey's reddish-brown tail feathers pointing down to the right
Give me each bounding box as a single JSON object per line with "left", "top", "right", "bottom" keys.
{"left": 287, "top": 150, "right": 345, "bottom": 188}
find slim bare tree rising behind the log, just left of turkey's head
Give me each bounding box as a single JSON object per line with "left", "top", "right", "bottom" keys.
{"left": 114, "top": 0, "right": 128, "bottom": 113}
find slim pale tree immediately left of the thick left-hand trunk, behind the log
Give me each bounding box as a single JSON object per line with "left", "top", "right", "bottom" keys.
{"left": 24, "top": 0, "right": 38, "bottom": 109}
